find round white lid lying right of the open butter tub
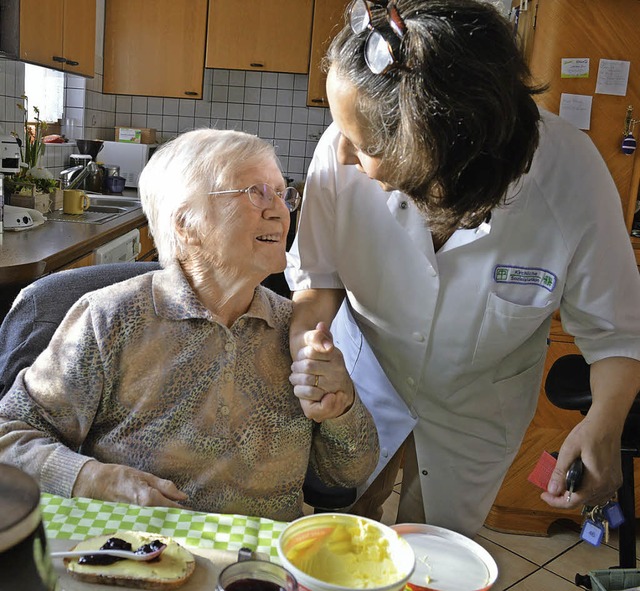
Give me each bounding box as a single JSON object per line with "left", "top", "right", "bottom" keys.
{"left": 391, "top": 523, "right": 498, "bottom": 591}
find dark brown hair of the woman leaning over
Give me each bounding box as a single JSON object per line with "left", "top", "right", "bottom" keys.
{"left": 324, "top": 0, "right": 546, "bottom": 235}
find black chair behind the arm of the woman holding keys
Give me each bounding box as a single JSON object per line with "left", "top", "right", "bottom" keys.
{"left": 544, "top": 355, "right": 640, "bottom": 568}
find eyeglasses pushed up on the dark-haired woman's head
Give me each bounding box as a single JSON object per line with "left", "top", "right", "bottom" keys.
{"left": 349, "top": 0, "right": 407, "bottom": 74}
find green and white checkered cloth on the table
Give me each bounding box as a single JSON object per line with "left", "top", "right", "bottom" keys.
{"left": 40, "top": 493, "right": 286, "bottom": 558}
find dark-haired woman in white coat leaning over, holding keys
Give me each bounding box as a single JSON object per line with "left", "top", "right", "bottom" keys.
{"left": 287, "top": 0, "right": 640, "bottom": 535}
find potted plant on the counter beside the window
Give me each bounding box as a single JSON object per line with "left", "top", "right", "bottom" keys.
{"left": 4, "top": 95, "right": 61, "bottom": 213}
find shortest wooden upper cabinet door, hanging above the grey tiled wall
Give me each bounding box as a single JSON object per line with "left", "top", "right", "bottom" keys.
{"left": 206, "top": 0, "right": 314, "bottom": 74}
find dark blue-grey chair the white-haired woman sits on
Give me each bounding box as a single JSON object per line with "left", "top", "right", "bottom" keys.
{"left": 0, "top": 262, "right": 356, "bottom": 512}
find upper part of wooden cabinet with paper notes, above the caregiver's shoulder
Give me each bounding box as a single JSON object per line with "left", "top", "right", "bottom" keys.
{"left": 522, "top": 0, "right": 640, "bottom": 235}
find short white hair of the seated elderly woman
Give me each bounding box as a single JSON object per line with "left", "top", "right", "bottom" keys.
{"left": 138, "top": 129, "right": 278, "bottom": 267}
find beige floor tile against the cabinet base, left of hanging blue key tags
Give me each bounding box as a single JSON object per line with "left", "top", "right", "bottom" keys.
{"left": 478, "top": 523, "right": 580, "bottom": 566}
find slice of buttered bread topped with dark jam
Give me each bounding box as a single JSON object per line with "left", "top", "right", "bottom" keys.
{"left": 64, "top": 531, "right": 196, "bottom": 589}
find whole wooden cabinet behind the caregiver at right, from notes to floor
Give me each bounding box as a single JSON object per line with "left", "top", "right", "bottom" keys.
{"left": 486, "top": 0, "right": 640, "bottom": 535}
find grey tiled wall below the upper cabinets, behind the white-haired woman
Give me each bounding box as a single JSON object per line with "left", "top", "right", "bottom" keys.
{"left": 77, "top": 69, "right": 331, "bottom": 180}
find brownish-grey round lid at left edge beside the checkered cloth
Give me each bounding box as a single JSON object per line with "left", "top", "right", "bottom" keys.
{"left": 0, "top": 464, "right": 40, "bottom": 552}
